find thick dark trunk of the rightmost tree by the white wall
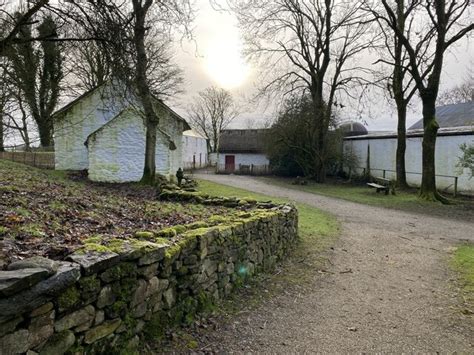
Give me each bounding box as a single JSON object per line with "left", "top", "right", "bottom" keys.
{"left": 420, "top": 94, "right": 447, "bottom": 203}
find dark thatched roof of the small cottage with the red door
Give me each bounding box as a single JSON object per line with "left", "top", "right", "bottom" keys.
{"left": 219, "top": 129, "right": 268, "bottom": 153}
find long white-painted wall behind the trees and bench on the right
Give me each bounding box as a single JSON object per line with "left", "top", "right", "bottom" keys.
{"left": 344, "top": 133, "right": 474, "bottom": 195}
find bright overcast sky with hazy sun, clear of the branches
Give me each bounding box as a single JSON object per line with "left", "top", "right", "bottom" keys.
{"left": 173, "top": 0, "right": 474, "bottom": 134}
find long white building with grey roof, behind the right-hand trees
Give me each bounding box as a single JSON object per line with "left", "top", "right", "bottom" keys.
{"left": 344, "top": 102, "right": 474, "bottom": 195}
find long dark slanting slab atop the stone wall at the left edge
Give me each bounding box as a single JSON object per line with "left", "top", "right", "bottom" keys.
{"left": 0, "top": 262, "right": 81, "bottom": 323}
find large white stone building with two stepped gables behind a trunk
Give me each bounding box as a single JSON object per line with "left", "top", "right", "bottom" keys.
{"left": 54, "top": 84, "right": 190, "bottom": 182}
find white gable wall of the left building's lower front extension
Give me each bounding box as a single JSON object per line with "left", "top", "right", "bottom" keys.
{"left": 88, "top": 109, "right": 174, "bottom": 182}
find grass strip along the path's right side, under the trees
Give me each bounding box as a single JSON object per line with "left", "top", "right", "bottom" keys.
{"left": 264, "top": 177, "right": 474, "bottom": 218}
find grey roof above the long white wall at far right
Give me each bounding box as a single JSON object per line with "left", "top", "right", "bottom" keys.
{"left": 408, "top": 101, "right": 474, "bottom": 130}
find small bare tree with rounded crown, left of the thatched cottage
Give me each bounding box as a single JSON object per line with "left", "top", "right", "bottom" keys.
{"left": 189, "top": 86, "right": 239, "bottom": 153}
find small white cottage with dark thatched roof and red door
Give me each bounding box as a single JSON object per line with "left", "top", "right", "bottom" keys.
{"left": 215, "top": 129, "right": 270, "bottom": 174}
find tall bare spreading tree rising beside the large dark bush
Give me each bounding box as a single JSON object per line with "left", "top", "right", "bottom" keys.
{"left": 231, "top": 0, "right": 371, "bottom": 182}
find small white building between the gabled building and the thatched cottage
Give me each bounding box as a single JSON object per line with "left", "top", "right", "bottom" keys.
{"left": 183, "top": 130, "right": 209, "bottom": 170}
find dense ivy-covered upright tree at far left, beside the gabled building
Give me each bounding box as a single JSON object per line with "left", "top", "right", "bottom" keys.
{"left": 8, "top": 16, "right": 63, "bottom": 147}
